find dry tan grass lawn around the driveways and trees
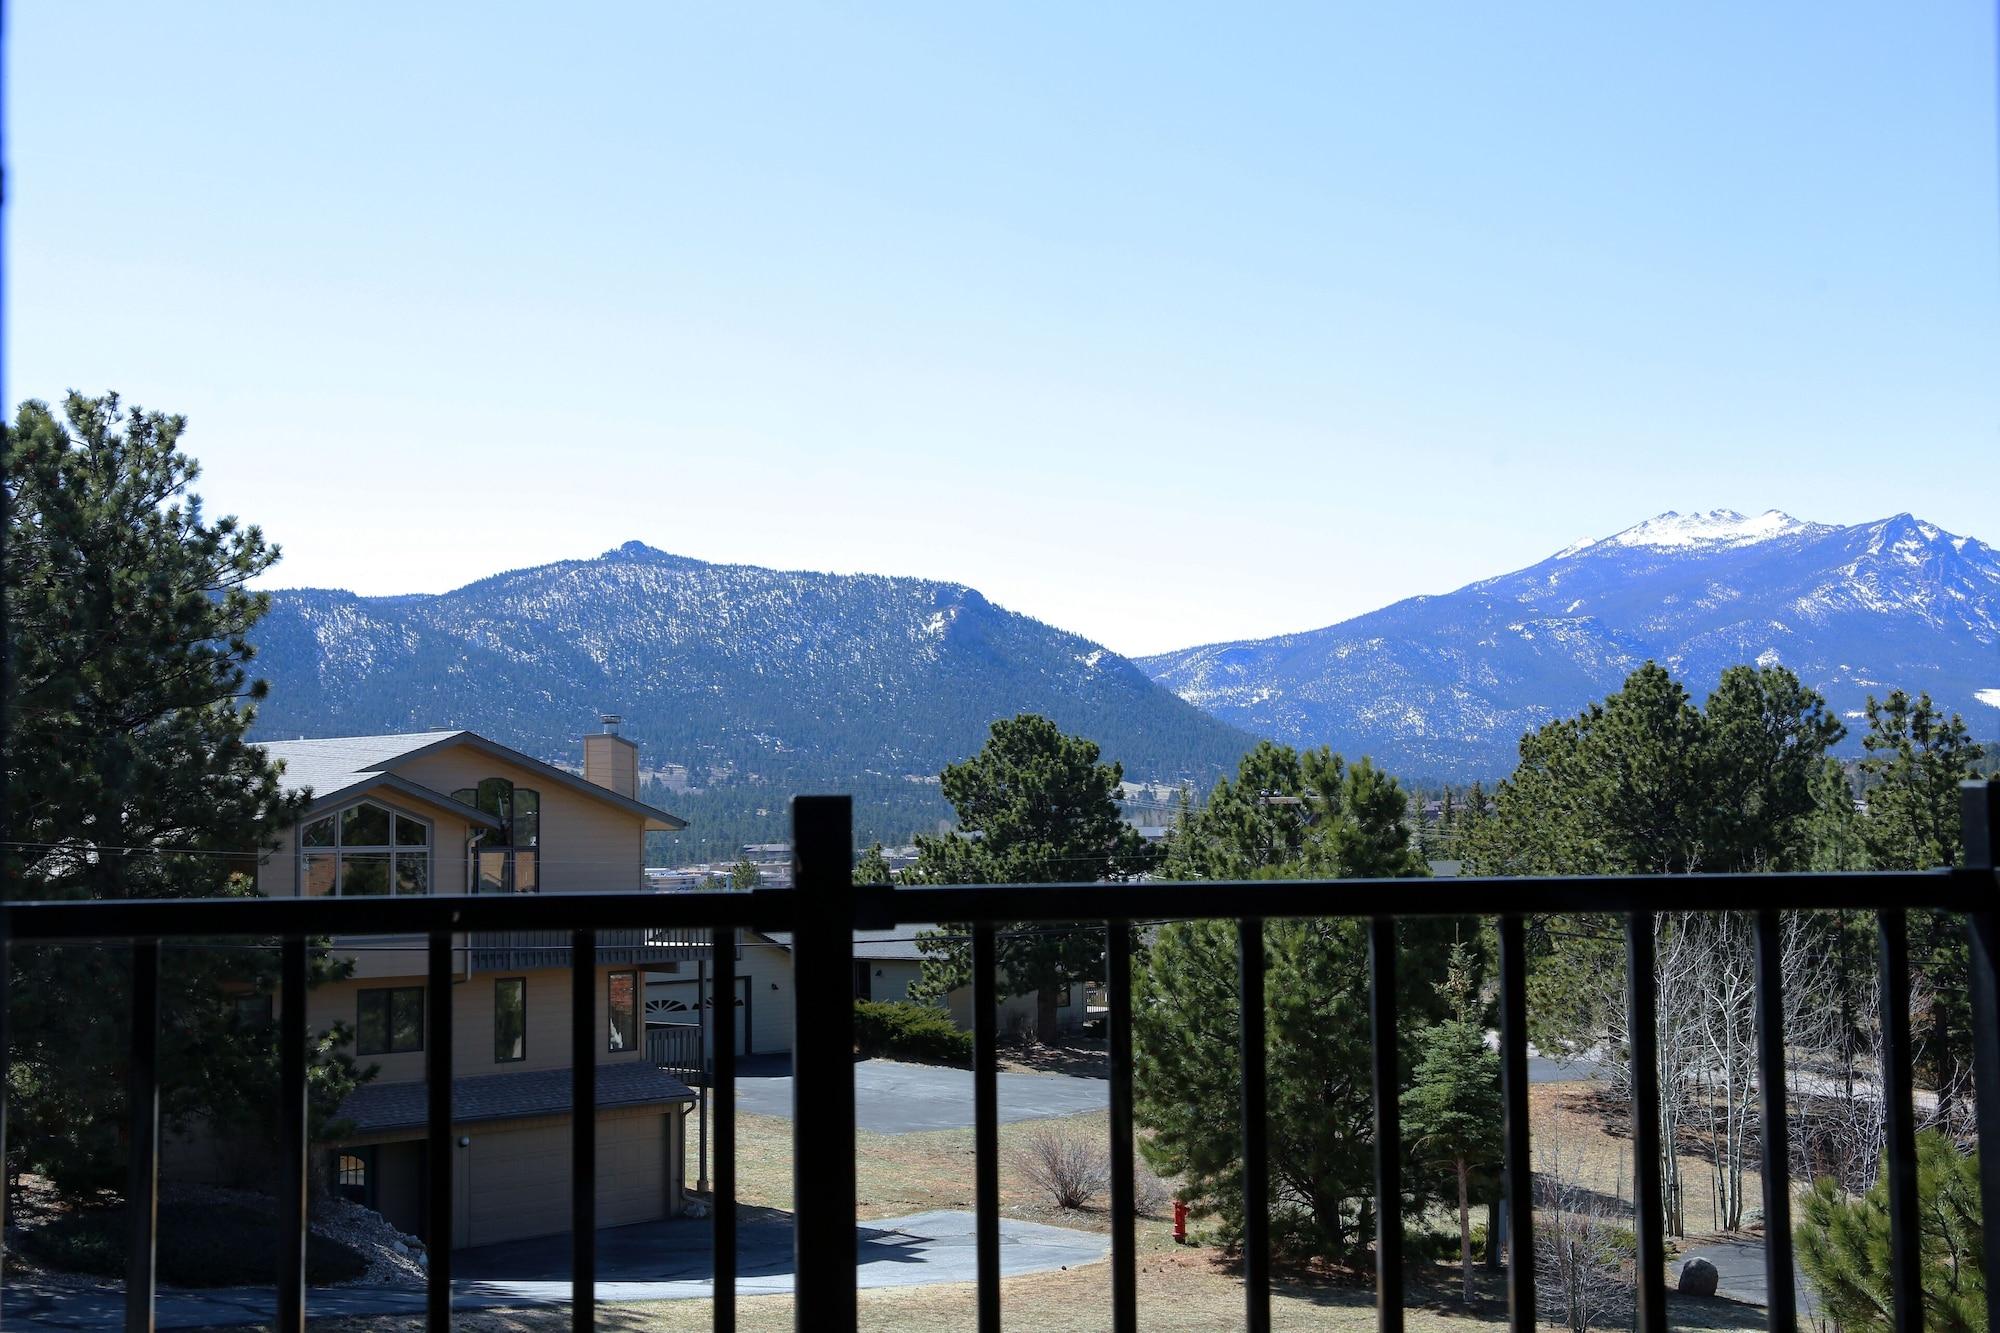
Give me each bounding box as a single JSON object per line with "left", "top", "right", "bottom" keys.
{"left": 296, "top": 1085, "right": 1762, "bottom": 1333}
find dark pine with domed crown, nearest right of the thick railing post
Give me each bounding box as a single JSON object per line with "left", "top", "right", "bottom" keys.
{"left": 904, "top": 713, "right": 1156, "bottom": 1041}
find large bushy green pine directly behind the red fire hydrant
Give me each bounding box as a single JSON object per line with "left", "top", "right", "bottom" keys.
{"left": 1132, "top": 745, "right": 1472, "bottom": 1263}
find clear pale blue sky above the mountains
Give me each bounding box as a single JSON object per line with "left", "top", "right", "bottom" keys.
{"left": 6, "top": 0, "right": 2000, "bottom": 652}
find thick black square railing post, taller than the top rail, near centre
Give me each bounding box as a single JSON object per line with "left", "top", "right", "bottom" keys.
{"left": 792, "top": 797, "right": 858, "bottom": 1333}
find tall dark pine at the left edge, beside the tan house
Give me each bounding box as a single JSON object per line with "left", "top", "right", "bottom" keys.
{"left": 0, "top": 394, "right": 368, "bottom": 1197}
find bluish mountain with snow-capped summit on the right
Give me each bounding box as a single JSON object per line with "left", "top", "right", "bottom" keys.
{"left": 1136, "top": 510, "right": 2000, "bottom": 779}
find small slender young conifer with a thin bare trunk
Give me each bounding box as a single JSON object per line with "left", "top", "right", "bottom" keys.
{"left": 1402, "top": 945, "right": 1500, "bottom": 1305}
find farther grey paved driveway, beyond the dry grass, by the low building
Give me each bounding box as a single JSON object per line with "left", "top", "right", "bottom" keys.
{"left": 736, "top": 1057, "right": 1110, "bottom": 1135}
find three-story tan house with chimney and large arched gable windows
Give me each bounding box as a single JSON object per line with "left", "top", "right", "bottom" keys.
{"left": 240, "top": 731, "right": 708, "bottom": 1247}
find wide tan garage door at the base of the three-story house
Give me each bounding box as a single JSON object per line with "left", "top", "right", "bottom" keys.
{"left": 458, "top": 1115, "right": 672, "bottom": 1245}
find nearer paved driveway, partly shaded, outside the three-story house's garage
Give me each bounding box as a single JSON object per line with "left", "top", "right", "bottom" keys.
{"left": 0, "top": 1211, "right": 1110, "bottom": 1329}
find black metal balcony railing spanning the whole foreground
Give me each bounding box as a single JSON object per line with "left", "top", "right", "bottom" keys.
{"left": 0, "top": 783, "right": 2000, "bottom": 1333}
